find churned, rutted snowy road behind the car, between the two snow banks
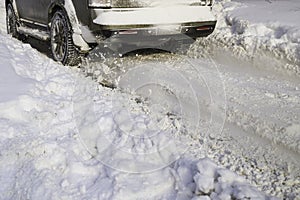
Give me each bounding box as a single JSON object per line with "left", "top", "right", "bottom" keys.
{"left": 84, "top": 39, "right": 300, "bottom": 197}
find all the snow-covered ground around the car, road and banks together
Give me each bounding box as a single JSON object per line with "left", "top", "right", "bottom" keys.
{"left": 0, "top": 1, "right": 300, "bottom": 199}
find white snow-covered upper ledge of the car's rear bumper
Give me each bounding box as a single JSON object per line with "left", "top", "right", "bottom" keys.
{"left": 92, "top": 5, "right": 216, "bottom": 27}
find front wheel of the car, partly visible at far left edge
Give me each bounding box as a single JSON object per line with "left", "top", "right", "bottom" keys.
{"left": 6, "top": 3, "right": 19, "bottom": 38}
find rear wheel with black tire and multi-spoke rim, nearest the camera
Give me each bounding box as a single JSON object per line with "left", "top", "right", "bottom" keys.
{"left": 50, "top": 10, "right": 81, "bottom": 66}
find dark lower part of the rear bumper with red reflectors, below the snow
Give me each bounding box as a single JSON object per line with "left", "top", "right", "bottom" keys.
{"left": 86, "top": 21, "right": 216, "bottom": 48}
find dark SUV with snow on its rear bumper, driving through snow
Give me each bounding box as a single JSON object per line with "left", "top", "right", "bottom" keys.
{"left": 5, "top": 0, "right": 217, "bottom": 65}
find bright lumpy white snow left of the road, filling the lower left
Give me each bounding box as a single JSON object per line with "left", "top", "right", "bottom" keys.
{"left": 0, "top": 2, "right": 269, "bottom": 199}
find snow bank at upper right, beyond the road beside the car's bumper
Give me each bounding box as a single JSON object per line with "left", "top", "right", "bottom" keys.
{"left": 192, "top": 0, "right": 300, "bottom": 75}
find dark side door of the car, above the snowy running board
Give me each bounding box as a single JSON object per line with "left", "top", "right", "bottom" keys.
{"left": 15, "top": 0, "right": 51, "bottom": 24}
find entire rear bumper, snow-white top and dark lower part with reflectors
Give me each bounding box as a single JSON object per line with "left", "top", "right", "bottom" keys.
{"left": 83, "top": 6, "right": 216, "bottom": 45}
